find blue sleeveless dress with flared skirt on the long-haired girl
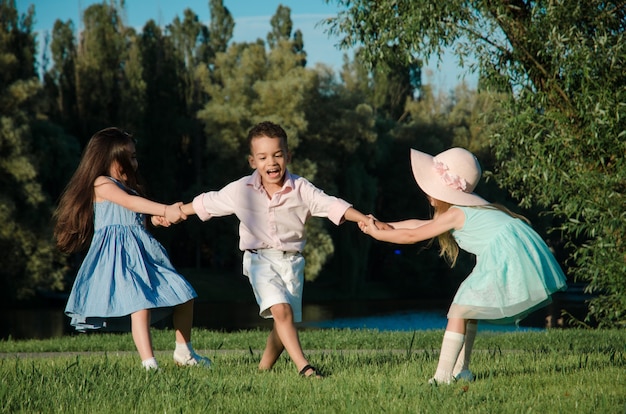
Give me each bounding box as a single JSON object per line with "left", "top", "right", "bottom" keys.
{"left": 65, "top": 178, "right": 197, "bottom": 331}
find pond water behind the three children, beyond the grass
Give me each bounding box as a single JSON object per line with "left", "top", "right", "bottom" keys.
{"left": 0, "top": 301, "right": 549, "bottom": 339}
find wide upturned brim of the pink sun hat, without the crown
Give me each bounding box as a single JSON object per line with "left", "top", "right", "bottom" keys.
{"left": 411, "top": 149, "right": 489, "bottom": 206}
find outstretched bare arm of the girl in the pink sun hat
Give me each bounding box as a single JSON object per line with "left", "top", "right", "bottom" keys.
{"left": 359, "top": 208, "right": 465, "bottom": 244}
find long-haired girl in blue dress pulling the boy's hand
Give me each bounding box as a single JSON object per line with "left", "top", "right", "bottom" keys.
{"left": 55, "top": 128, "right": 211, "bottom": 369}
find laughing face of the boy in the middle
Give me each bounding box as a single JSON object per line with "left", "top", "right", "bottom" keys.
{"left": 248, "top": 136, "right": 289, "bottom": 188}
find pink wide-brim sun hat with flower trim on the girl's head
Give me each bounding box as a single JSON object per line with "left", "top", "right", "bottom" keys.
{"left": 411, "top": 148, "right": 489, "bottom": 206}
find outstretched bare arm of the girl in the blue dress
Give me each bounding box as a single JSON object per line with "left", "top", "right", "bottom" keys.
{"left": 94, "top": 177, "right": 187, "bottom": 223}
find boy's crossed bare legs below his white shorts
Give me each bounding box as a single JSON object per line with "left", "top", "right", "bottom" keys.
{"left": 259, "top": 303, "right": 309, "bottom": 371}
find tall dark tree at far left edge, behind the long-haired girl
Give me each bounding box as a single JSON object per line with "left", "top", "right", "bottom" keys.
{"left": 0, "top": 0, "right": 64, "bottom": 301}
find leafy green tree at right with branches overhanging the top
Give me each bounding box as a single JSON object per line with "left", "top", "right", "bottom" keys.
{"left": 329, "top": 0, "right": 626, "bottom": 326}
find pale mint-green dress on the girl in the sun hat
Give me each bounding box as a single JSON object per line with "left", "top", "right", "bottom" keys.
{"left": 448, "top": 206, "right": 566, "bottom": 323}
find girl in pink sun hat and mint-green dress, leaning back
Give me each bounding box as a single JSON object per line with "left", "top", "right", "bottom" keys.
{"left": 359, "top": 148, "right": 566, "bottom": 384}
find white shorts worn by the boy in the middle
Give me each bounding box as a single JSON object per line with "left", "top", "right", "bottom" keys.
{"left": 243, "top": 249, "right": 304, "bottom": 322}
